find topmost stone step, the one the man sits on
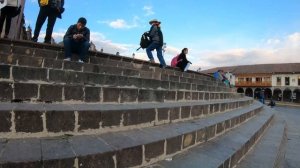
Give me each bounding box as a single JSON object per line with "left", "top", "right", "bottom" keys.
{"left": 0, "top": 39, "right": 221, "bottom": 83}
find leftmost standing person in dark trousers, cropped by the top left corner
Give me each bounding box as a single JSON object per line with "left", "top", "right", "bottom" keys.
{"left": 0, "top": 0, "right": 21, "bottom": 38}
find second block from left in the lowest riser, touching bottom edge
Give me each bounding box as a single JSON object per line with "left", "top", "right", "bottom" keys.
{"left": 116, "top": 146, "right": 143, "bottom": 167}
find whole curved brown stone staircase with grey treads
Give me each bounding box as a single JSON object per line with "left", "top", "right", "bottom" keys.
{"left": 0, "top": 39, "right": 286, "bottom": 168}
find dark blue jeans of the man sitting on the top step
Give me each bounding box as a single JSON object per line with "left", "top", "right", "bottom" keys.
{"left": 64, "top": 38, "right": 90, "bottom": 60}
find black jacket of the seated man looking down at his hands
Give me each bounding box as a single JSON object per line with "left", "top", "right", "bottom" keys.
{"left": 64, "top": 24, "right": 90, "bottom": 42}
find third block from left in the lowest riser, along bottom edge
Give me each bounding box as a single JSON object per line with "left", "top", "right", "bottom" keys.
{"left": 145, "top": 140, "right": 165, "bottom": 161}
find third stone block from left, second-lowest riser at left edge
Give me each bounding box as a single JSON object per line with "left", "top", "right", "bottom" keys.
{"left": 40, "top": 85, "right": 63, "bottom": 101}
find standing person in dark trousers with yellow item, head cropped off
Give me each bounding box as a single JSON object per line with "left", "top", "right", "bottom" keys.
{"left": 31, "top": 0, "right": 65, "bottom": 44}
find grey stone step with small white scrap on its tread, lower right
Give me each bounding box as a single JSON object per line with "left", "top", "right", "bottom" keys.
{"left": 149, "top": 107, "right": 274, "bottom": 168}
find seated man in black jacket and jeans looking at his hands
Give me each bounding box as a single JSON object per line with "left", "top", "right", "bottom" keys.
{"left": 64, "top": 17, "right": 90, "bottom": 63}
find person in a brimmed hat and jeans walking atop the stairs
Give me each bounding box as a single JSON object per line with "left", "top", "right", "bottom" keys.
{"left": 146, "top": 19, "right": 166, "bottom": 68}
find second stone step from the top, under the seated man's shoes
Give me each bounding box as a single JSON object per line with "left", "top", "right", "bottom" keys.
{"left": 0, "top": 55, "right": 225, "bottom": 87}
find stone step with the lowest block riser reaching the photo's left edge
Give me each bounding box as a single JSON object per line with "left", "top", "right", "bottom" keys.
{"left": 0, "top": 98, "right": 253, "bottom": 138}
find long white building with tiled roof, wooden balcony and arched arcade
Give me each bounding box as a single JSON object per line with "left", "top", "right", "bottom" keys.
{"left": 202, "top": 63, "right": 300, "bottom": 103}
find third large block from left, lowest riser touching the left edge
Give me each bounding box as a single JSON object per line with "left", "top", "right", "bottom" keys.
{"left": 46, "top": 110, "right": 75, "bottom": 132}
